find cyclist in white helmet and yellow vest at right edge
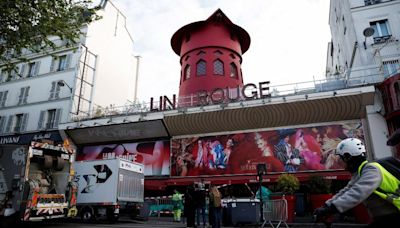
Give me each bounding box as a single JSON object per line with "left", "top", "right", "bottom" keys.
{"left": 314, "top": 138, "right": 400, "bottom": 227}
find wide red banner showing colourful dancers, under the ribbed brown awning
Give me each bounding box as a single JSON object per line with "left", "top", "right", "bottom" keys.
{"left": 171, "top": 121, "right": 364, "bottom": 176}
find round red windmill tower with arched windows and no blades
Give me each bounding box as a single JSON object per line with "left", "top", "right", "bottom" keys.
{"left": 171, "top": 9, "right": 250, "bottom": 106}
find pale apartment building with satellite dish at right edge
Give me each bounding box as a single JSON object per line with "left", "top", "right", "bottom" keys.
{"left": 326, "top": 0, "right": 400, "bottom": 156}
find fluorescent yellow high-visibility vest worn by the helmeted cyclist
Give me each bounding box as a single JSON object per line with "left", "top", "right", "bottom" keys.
{"left": 358, "top": 161, "right": 400, "bottom": 210}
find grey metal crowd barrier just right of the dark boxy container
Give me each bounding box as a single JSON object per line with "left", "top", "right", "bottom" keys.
{"left": 261, "top": 199, "right": 289, "bottom": 228}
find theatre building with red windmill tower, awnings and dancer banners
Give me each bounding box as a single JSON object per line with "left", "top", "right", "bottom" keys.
{"left": 61, "top": 10, "right": 392, "bottom": 194}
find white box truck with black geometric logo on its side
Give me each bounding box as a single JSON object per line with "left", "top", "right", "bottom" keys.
{"left": 74, "top": 158, "right": 144, "bottom": 222}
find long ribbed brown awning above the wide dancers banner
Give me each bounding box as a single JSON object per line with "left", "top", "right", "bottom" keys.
{"left": 164, "top": 86, "right": 375, "bottom": 136}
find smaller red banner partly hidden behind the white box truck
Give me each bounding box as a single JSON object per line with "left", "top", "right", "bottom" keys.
{"left": 76, "top": 140, "right": 170, "bottom": 176}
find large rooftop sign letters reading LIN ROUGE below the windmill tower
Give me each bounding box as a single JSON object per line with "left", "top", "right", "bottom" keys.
{"left": 150, "top": 81, "right": 271, "bottom": 111}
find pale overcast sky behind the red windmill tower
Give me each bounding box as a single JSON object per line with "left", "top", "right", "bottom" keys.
{"left": 113, "top": 0, "right": 330, "bottom": 102}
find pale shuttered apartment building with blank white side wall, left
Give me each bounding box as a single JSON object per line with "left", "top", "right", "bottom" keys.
{"left": 0, "top": 1, "right": 138, "bottom": 144}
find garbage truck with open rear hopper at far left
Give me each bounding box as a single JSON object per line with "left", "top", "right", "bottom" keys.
{"left": 0, "top": 142, "right": 77, "bottom": 227}
